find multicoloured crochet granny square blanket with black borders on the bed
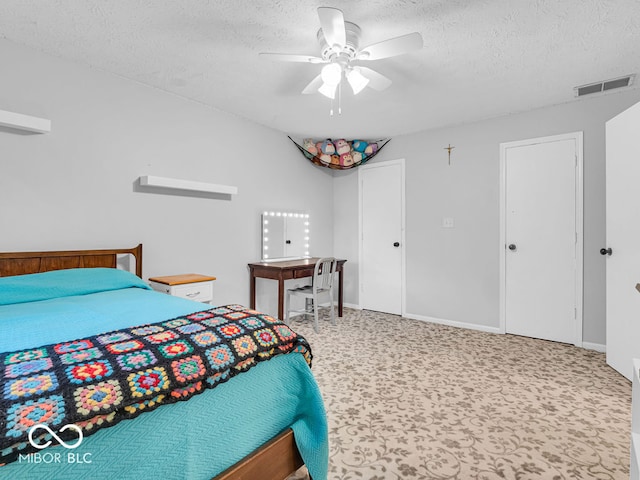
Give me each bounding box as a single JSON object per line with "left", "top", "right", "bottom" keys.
{"left": 0, "top": 305, "right": 312, "bottom": 465}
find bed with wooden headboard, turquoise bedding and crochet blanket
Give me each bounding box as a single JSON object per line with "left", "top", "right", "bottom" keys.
{"left": 0, "top": 245, "right": 328, "bottom": 480}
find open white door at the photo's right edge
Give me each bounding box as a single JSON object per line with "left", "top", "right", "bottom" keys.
{"left": 603, "top": 103, "right": 640, "bottom": 380}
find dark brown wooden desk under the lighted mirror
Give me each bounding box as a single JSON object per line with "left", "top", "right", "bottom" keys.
{"left": 249, "top": 258, "right": 346, "bottom": 320}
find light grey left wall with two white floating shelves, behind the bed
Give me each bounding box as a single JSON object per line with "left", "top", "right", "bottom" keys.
{"left": 0, "top": 40, "right": 333, "bottom": 313}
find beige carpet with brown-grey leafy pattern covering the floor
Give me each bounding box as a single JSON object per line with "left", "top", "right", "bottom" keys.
{"left": 292, "top": 309, "right": 631, "bottom": 480}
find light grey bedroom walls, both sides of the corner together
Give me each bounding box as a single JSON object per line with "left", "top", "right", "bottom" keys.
{"left": 5, "top": 36, "right": 640, "bottom": 344}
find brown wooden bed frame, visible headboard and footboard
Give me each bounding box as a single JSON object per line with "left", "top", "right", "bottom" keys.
{"left": 0, "top": 244, "right": 304, "bottom": 480}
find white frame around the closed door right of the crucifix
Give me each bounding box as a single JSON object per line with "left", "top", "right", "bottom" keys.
{"left": 499, "top": 132, "right": 584, "bottom": 347}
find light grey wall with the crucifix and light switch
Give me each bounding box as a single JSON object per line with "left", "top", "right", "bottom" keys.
{"left": 334, "top": 89, "right": 640, "bottom": 345}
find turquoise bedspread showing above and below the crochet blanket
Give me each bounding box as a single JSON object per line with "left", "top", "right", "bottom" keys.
{"left": 0, "top": 270, "right": 328, "bottom": 479}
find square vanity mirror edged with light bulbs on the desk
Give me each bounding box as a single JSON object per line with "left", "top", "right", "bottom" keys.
{"left": 262, "top": 212, "right": 310, "bottom": 262}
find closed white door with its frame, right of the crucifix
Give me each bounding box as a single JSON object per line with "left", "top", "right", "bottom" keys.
{"left": 501, "top": 132, "right": 582, "bottom": 346}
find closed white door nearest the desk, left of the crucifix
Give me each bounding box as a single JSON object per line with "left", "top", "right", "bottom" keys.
{"left": 359, "top": 160, "right": 404, "bottom": 315}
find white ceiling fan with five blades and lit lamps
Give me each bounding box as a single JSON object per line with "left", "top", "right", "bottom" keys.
{"left": 260, "top": 7, "right": 423, "bottom": 99}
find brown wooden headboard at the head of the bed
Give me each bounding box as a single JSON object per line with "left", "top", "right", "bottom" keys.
{"left": 0, "top": 244, "right": 142, "bottom": 278}
